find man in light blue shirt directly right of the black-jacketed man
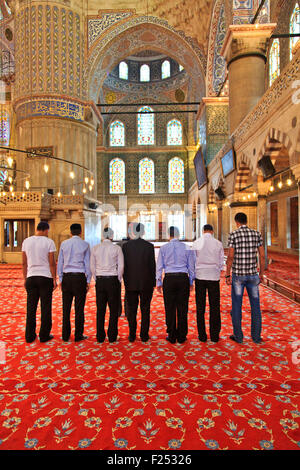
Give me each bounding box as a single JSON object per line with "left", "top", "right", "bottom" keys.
{"left": 156, "top": 227, "right": 195, "bottom": 344}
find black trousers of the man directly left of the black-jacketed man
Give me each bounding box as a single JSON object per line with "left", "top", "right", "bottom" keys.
{"left": 96, "top": 276, "right": 121, "bottom": 343}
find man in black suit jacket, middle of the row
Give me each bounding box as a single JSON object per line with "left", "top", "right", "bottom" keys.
{"left": 123, "top": 223, "right": 156, "bottom": 342}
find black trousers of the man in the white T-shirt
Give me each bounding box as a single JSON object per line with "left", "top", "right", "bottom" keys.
{"left": 25, "top": 276, "right": 53, "bottom": 343}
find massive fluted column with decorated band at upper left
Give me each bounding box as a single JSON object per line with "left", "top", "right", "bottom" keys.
{"left": 13, "top": 0, "right": 99, "bottom": 196}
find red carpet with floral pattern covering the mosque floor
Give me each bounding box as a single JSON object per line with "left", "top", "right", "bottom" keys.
{"left": 0, "top": 265, "right": 300, "bottom": 450}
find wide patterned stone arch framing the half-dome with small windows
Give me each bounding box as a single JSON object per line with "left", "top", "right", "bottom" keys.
{"left": 84, "top": 16, "right": 206, "bottom": 102}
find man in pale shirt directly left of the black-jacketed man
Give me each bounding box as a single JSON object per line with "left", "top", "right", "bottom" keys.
{"left": 91, "top": 227, "right": 124, "bottom": 343}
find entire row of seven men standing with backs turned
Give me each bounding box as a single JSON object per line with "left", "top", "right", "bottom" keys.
{"left": 22, "top": 213, "right": 264, "bottom": 343}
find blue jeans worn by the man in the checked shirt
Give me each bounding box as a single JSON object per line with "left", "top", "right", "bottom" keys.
{"left": 231, "top": 274, "right": 261, "bottom": 343}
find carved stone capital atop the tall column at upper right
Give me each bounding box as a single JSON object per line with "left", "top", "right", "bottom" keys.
{"left": 221, "top": 23, "right": 277, "bottom": 66}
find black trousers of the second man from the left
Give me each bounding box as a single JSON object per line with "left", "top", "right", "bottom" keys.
{"left": 61, "top": 273, "right": 87, "bottom": 341}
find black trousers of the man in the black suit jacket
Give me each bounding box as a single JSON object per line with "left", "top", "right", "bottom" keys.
{"left": 126, "top": 288, "right": 153, "bottom": 341}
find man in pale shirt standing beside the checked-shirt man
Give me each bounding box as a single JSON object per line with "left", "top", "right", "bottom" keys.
{"left": 193, "top": 224, "right": 224, "bottom": 343}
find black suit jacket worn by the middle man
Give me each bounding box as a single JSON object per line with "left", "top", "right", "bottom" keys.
{"left": 123, "top": 238, "right": 156, "bottom": 291}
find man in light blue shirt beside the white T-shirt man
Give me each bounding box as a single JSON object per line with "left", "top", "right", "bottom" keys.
{"left": 57, "top": 224, "right": 91, "bottom": 341}
